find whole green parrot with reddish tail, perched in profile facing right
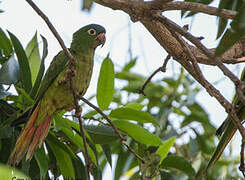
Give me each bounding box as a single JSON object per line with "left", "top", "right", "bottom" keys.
{"left": 8, "top": 24, "right": 106, "bottom": 165}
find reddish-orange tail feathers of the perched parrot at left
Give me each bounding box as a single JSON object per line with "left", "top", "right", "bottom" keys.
{"left": 8, "top": 105, "right": 52, "bottom": 165}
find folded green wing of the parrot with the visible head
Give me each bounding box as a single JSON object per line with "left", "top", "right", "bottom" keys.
{"left": 35, "top": 51, "right": 68, "bottom": 104}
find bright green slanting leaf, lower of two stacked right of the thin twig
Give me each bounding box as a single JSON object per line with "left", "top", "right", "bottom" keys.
{"left": 113, "top": 120, "right": 162, "bottom": 146}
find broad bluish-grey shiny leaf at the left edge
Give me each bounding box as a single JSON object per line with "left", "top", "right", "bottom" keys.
{"left": 0, "top": 55, "right": 20, "bottom": 85}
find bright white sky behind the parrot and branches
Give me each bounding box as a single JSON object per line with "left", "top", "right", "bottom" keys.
{"left": 0, "top": 0, "right": 244, "bottom": 178}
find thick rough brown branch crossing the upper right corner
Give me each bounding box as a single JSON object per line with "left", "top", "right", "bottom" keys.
{"left": 96, "top": 0, "right": 245, "bottom": 65}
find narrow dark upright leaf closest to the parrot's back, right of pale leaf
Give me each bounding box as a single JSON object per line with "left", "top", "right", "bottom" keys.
{"left": 31, "top": 35, "right": 48, "bottom": 98}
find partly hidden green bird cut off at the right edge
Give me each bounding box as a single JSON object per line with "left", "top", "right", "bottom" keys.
{"left": 206, "top": 68, "right": 245, "bottom": 172}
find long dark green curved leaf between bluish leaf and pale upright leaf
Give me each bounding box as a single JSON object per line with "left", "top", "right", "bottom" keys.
{"left": 8, "top": 31, "right": 32, "bottom": 93}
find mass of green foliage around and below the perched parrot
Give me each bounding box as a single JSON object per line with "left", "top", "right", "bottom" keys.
{"left": 0, "top": 29, "right": 242, "bottom": 179}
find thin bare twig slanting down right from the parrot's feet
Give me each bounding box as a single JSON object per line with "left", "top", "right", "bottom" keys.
{"left": 80, "top": 97, "right": 145, "bottom": 163}
